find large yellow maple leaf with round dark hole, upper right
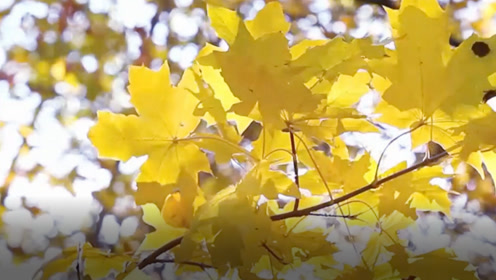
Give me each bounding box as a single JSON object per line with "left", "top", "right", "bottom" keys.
{"left": 371, "top": 0, "right": 496, "bottom": 151}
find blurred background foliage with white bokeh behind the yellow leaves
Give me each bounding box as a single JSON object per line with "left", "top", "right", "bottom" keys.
{"left": 0, "top": 0, "right": 496, "bottom": 279}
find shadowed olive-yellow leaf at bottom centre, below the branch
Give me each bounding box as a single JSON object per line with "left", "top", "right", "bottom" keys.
{"left": 181, "top": 186, "right": 271, "bottom": 273}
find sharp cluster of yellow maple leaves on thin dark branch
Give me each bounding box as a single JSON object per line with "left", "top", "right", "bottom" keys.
{"left": 41, "top": 0, "right": 496, "bottom": 279}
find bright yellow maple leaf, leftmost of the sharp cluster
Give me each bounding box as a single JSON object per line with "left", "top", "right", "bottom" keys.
{"left": 88, "top": 64, "right": 210, "bottom": 185}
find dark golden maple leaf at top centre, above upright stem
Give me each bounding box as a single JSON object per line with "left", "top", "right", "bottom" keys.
{"left": 199, "top": 2, "right": 322, "bottom": 128}
